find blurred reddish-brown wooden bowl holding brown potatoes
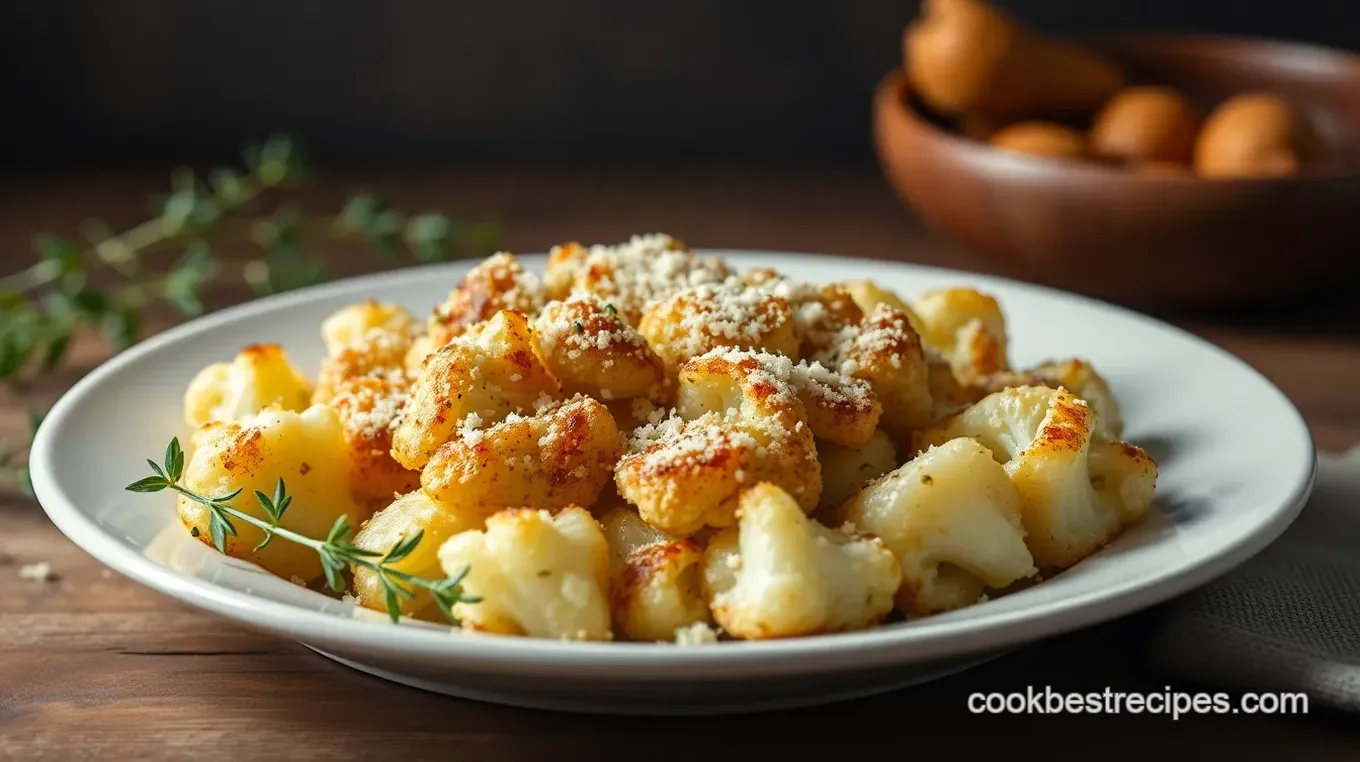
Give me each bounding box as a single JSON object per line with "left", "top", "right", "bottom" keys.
{"left": 874, "top": 35, "right": 1360, "bottom": 308}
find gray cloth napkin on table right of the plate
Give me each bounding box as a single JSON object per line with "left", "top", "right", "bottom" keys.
{"left": 1149, "top": 448, "right": 1360, "bottom": 712}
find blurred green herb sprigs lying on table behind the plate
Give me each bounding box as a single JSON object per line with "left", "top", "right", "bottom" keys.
{"left": 0, "top": 136, "right": 499, "bottom": 498}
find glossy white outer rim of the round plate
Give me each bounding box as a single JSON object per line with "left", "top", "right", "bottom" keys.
{"left": 30, "top": 249, "right": 1316, "bottom": 680}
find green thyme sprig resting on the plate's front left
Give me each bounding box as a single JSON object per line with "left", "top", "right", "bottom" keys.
{"left": 126, "top": 438, "right": 481, "bottom": 625}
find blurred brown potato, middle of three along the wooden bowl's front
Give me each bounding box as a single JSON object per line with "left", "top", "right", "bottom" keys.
{"left": 1091, "top": 87, "right": 1200, "bottom": 165}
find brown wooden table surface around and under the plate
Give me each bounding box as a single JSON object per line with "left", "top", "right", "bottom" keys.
{"left": 0, "top": 167, "right": 1360, "bottom": 761}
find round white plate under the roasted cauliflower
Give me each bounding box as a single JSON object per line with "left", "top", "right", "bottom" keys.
{"left": 31, "top": 252, "right": 1314, "bottom": 713}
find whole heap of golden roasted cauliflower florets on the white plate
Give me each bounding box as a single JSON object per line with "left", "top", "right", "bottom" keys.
{"left": 164, "top": 234, "right": 1157, "bottom": 646}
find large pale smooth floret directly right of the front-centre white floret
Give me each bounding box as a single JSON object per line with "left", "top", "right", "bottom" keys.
{"left": 838, "top": 438, "right": 1036, "bottom": 616}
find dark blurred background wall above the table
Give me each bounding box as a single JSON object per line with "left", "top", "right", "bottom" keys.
{"left": 0, "top": 0, "right": 1360, "bottom": 166}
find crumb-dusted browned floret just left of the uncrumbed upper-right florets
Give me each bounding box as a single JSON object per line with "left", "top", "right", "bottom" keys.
{"left": 819, "top": 305, "right": 934, "bottom": 438}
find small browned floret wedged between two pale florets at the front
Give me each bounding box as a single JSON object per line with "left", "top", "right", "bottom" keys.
{"left": 600, "top": 506, "right": 709, "bottom": 641}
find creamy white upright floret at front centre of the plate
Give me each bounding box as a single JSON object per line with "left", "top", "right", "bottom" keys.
{"left": 703, "top": 483, "right": 902, "bottom": 640}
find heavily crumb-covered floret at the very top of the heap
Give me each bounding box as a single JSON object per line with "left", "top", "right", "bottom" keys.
{"left": 544, "top": 233, "right": 733, "bottom": 325}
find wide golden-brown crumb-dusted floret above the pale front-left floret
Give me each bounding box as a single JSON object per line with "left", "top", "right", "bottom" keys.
{"left": 420, "top": 396, "right": 619, "bottom": 516}
